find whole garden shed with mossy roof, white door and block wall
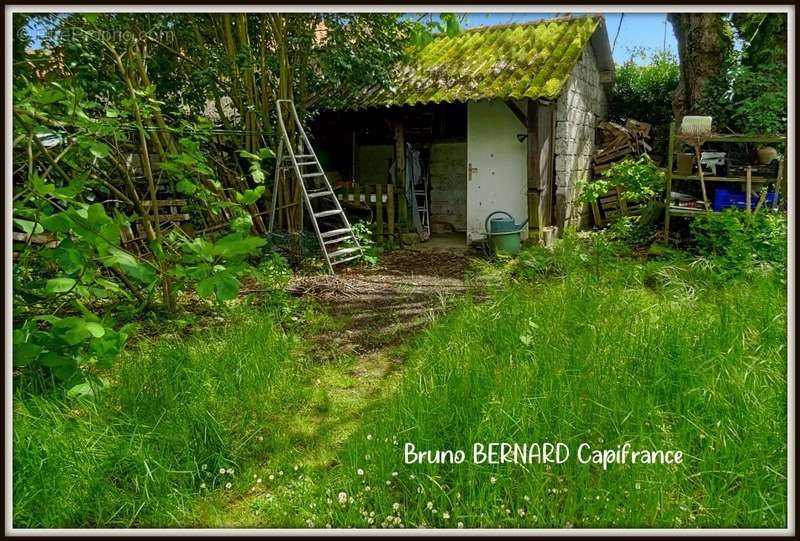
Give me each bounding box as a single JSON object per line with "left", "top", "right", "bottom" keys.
{"left": 311, "top": 16, "right": 614, "bottom": 243}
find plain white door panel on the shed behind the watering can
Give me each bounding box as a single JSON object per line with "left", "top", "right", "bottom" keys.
{"left": 467, "top": 101, "right": 528, "bottom": 241}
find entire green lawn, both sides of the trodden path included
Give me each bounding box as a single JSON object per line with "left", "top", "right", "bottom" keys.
{"left": 14, "top": 243, "right": 787, "bottom": 528}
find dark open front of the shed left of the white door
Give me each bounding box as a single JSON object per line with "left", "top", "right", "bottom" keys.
{"left": 311, "top": 103, "right": 467, "bottom": 246}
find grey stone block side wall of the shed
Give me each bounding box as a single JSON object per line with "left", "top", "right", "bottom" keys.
{"left": 554, "top": 44, "right": 608, "bottom": 230}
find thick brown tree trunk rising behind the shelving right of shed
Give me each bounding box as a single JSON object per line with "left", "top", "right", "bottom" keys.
{"left": 668, "top": 13, "right": 733, "bottom": 125}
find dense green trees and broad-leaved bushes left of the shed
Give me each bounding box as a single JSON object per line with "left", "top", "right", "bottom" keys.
{"left": 13, "top": 13, "right": 446, "bottom": 393}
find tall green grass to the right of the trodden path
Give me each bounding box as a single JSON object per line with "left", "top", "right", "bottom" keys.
{"left": 314, "top": 245, "right": 786, "bottom": 528}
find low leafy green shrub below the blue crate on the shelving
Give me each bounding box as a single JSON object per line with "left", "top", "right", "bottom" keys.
{"left": 690, "top": 209, "right": 787, "bottom": 270}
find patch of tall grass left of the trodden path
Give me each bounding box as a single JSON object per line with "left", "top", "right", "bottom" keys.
{"left": 14, "top": 312, "right": 307, "bottom": 527}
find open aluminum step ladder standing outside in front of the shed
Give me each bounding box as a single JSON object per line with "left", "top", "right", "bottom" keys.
{"left": 269, "top": 100, "right": 364, "bottom": 274}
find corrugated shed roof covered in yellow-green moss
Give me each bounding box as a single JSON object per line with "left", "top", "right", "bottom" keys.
{"left": 322, "top": 16, "right": 613, "bottom": 109}
